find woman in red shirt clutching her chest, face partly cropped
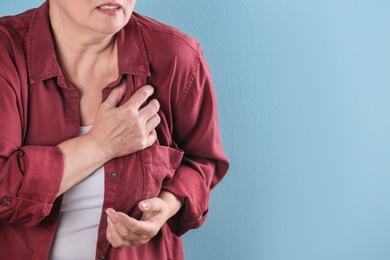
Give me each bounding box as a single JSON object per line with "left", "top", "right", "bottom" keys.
{"left": 0, "top": 0, "right": 228, "bottom": 260}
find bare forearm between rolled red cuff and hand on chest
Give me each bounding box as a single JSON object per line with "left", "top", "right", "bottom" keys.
{"left": 57, "top": 134, "right": 109, "bottom": 197}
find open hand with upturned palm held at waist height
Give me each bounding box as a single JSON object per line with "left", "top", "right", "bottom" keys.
{"left": 106, "top": 191, "right": 181, "bottom": 247}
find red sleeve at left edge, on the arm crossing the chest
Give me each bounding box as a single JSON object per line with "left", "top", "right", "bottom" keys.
{"left": 0, "top": 76, "right": 64, "bottom": 226}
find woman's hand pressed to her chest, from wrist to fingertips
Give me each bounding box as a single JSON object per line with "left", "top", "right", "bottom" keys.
{"left": 88, "top": 81, "right": 160, "bottom": 161}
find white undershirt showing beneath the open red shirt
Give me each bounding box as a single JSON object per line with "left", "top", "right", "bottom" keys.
{"left": 49, "top": 126, "right": 104, "bottom": 260}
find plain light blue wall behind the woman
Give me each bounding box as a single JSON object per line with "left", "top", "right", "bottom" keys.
{"left": 0, "top": 0, "right": 390, "bottom": 260}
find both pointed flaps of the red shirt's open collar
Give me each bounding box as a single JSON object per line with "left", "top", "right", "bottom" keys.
{"left": 27, "top": 1, "right": 150, "bottom": 84}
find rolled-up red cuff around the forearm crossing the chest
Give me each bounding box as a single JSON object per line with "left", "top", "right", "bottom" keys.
{"left": 0, "top": 146, "right": 63, "bottom": 226}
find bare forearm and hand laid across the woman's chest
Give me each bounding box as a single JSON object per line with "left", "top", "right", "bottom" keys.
{"left": 57, "top": 81, "right": 160, "bottom": 196}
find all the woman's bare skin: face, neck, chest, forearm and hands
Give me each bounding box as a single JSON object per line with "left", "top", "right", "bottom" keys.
{"left": 50, "top": 0, "right": 182, "bottom": 247}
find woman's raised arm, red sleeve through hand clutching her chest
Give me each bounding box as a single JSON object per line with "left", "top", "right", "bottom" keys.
{"left": 0, "top": 76, "right": 160, "bottom": 226}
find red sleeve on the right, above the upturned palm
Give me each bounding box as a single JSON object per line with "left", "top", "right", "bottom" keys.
{"left": 163, "top": 44, "right": 229, "bottom": 235}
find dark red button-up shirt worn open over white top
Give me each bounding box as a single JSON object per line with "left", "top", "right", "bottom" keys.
{"left": 0, "top": 2, "right": 228, "bottom": 260}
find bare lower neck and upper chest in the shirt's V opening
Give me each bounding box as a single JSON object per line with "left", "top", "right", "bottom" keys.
{"left": 54, "top": 21, "right": 119, "bottom": 125}
